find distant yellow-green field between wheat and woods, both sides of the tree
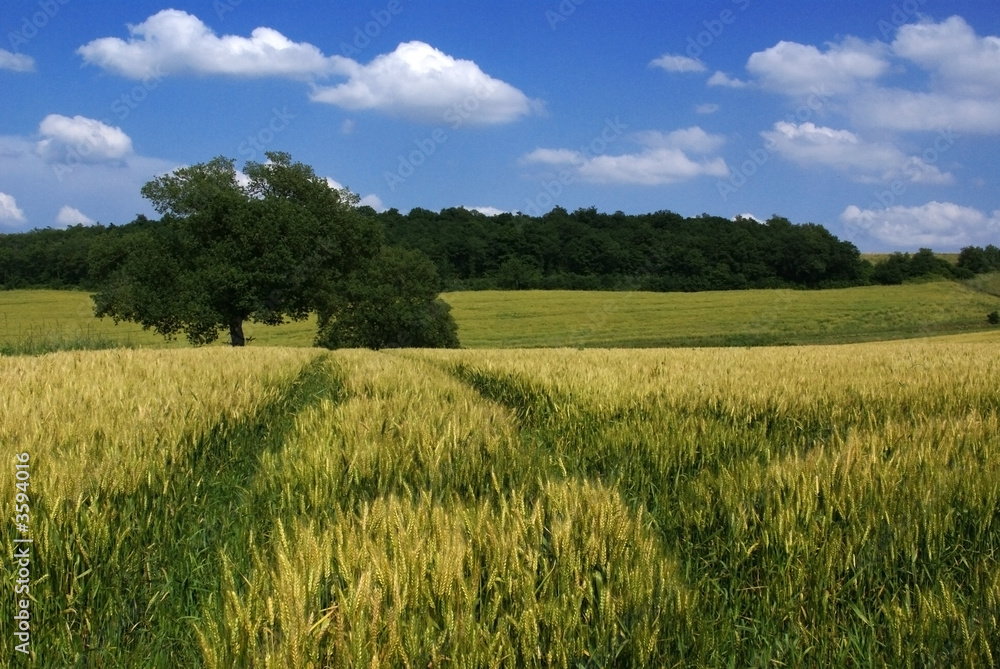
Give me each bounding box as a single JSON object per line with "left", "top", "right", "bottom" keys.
{"left": 0, "top": 275, "right": 1000, "bottom": 350}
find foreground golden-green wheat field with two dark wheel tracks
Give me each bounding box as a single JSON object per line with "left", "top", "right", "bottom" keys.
{"left": 0, "top": 334, "right": 1000, "bottom": 669}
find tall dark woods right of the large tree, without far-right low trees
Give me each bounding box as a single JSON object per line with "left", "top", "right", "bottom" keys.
{"left": 378, "top": 207, "right": 868, "bottom": 291}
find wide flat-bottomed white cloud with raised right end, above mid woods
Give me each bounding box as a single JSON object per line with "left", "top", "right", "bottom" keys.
{"left": 522, "top": 126, "right": 729, "bottom": 186}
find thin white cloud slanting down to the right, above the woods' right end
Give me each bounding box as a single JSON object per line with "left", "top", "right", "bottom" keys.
{"left": 761, "top": 121, "right": 954, "bottom": 184}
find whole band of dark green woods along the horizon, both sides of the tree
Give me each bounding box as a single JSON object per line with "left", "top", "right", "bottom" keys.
{"left": 0, "top": 207, "right": 1000, "bottom": 291}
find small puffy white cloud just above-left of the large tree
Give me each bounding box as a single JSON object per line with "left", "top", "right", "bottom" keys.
{"left": 35, "top": 114, "right": 132, "bottom": 165}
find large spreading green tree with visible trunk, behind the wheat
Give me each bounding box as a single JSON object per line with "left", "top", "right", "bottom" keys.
{"left": 91, "top": 152, "right": 381, "bottom": 346}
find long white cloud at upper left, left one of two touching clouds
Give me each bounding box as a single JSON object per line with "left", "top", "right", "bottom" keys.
{"left": 77, "top": 9, "right": 346, "bottom": 79}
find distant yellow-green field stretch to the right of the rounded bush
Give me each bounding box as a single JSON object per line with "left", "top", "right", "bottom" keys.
{"left": 444, "top": 281, "right": 1000, "bottom": 348}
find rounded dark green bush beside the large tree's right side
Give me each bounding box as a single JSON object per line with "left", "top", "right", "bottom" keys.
{"left": 316, "top": 247, "right": 458, "bottom": 349}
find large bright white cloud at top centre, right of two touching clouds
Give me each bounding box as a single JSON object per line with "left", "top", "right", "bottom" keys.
{"left": 311, "top": 42, "right": 540, "bottom": 127}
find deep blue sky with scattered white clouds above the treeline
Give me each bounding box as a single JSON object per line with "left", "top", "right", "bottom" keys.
{"left": 0, "top": 0, "right": 1000, "bottom": 251}
